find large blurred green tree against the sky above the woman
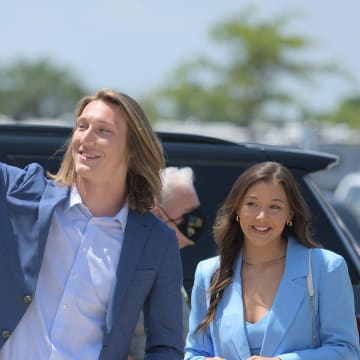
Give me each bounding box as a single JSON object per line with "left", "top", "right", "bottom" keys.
{"left": 146, "top": 8, "right": 340, "bottom": 126}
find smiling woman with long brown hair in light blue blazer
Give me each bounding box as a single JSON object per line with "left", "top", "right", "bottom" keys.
{"left": 185, "top": 162, "right": 360, "bottom": 360}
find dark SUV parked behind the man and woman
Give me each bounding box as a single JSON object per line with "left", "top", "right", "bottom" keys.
{"left": 0, "top": 125, "right": 360, "bottom": 334}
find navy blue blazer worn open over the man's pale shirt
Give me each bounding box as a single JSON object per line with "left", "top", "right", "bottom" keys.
{"left": 0, "top": 164, "right": 183, "bottom": 360}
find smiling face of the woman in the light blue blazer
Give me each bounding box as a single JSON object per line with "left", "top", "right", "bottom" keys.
{"left": 237, "top": 181, "right": 293, "bottom": 247}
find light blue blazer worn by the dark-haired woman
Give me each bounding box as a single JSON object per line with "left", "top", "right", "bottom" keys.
{"left": 185, "top": 239, "right": 360, "bottom": 360}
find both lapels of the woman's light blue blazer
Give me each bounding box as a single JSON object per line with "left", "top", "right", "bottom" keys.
{"left": 211, "top": 238, "right": 309, "bottom": 359}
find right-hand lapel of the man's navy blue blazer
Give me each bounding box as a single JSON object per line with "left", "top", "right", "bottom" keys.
{"left": 106, "top": 209, "right": 150, "bottom": 332}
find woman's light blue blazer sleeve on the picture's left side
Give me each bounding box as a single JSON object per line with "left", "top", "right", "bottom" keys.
{"left": 185, "top": 262, "right": 214, "bottom": 360}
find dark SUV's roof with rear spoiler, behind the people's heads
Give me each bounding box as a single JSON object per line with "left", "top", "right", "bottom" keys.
{"left": 0, "top": 124, "right": 339, "bottom": 174}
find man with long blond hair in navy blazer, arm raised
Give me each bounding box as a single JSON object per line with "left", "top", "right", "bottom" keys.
{"left": 0, "top": 90, "right": 183, "bottom": 360}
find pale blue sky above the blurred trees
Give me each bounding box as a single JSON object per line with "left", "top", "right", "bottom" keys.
{"left": 0, "top": 0, "right": 360, "bottom": 110}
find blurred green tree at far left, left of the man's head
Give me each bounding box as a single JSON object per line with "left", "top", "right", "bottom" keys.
{"left": 0, "top": 59, "right": 87, "bottom": 121}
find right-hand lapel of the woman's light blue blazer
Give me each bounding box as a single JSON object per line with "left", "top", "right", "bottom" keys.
{"left": 261, "top": 238, "right": 308, "bottom": 356}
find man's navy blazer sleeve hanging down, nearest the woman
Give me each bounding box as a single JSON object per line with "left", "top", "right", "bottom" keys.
{"left": 144, "top": 231, "right": 184, "bottom": 360}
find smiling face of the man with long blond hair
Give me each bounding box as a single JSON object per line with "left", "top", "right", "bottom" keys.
{"left": 72, "top": 100, "right": 129, "bottom": 188}
